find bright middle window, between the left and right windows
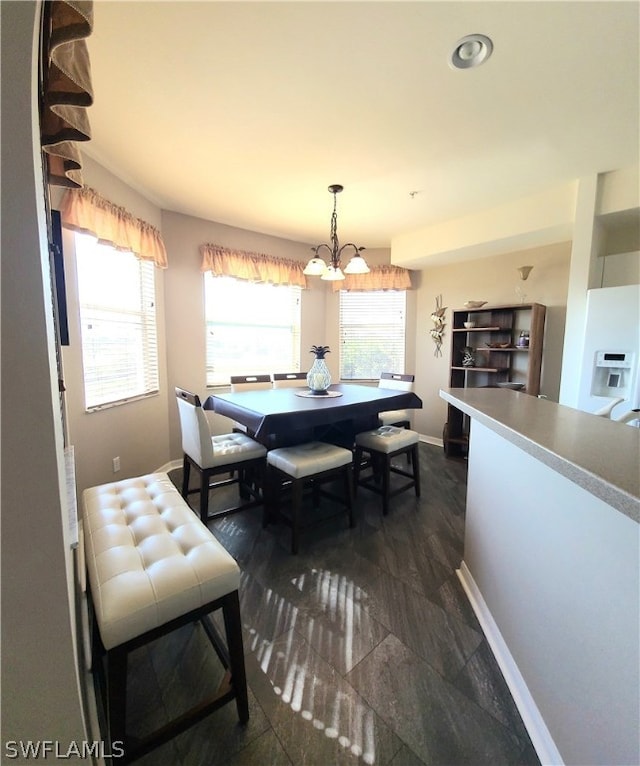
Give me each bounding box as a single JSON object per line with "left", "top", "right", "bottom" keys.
{"left": 204, "top": 272, "right": 301, "bottom": 386}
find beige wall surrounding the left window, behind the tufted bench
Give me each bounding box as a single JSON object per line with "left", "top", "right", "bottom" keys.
{"left": 62, "top": 158, "right": 169, "bottom": 493}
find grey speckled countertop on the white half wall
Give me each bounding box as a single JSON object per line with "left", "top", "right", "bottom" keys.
{"left": 440, "top": 388, "right": 640, "bottom": 522}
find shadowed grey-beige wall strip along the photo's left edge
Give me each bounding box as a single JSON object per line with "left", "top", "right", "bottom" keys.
{"left": 0, "top": 2, "right": 87, "bottom": 752}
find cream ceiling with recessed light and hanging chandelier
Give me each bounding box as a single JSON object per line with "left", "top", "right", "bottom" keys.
{"left": 86, "top": 0, "right": 640, "bottom": 258}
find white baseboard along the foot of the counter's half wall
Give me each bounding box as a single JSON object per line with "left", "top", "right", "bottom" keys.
{"left": 456, "top": 561, "right": 564, "bottom": 766}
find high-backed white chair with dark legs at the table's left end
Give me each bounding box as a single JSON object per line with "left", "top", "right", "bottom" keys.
{"left": 175, "top": 387, "right": 267, "bottom": 524}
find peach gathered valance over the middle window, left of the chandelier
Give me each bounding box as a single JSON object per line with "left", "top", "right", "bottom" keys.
{"left": 200, "top": 244, "right": 307, "bottom": 288}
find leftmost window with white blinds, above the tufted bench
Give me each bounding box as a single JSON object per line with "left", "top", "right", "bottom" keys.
{"left": 75, "top": 234, "right": 158, "bottom": 409}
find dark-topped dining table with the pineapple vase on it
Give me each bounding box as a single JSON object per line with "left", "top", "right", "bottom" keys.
{"left": 203, "top": 383, "right": 422, "bottom": 449}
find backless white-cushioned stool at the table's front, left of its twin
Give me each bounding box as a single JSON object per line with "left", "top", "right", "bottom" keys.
{"left": 262, "top": 442, "right": 355, "bottom": 554}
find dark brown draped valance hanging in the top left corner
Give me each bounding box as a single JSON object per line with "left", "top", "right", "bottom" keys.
{"left": 40, "top": 0, "right": 93, "bottom": 188}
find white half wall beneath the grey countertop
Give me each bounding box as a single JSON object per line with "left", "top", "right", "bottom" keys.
{"left": 464, "top": 420, "right": 640, "bottom": 766}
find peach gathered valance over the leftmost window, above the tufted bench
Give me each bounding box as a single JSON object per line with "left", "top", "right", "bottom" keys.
{"left": 60, "top": 186, "right": 168, "bottom": 269}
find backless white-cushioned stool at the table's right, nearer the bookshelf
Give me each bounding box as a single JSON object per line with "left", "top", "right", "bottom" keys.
{"left": 354, "top": 426, "right": 420, "bottom": 516}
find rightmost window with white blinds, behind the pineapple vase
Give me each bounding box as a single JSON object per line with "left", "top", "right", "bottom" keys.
{"left": 340, "top": 290, "right": 406, "bottom": 380}
